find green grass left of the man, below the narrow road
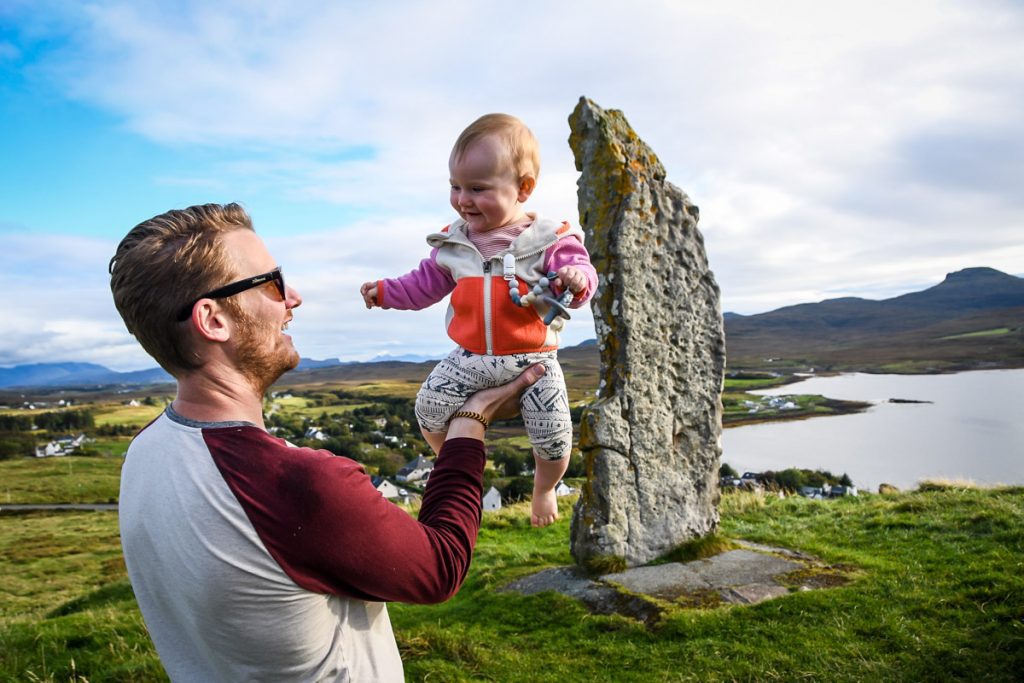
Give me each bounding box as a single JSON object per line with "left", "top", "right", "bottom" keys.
{"left": 0, "top": 512, "right": 166, "bottom": 683}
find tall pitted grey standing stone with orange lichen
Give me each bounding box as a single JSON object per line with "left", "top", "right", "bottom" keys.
{"left": 569, "top": 98, "right": 725, "bottom": 570}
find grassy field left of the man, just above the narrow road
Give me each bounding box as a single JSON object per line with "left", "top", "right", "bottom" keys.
{"left": 0, "top": 456, "right": 127, "bottom": 506}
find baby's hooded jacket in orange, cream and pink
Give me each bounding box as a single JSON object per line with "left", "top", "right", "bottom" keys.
{"left": 377, "top": 214, "right": 597, "bottom": 355}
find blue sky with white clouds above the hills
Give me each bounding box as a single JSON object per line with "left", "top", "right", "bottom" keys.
{"left": 0, "top": 0, "right": 1024, "bottom": 371}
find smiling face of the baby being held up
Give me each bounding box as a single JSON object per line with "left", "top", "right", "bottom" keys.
{"left": 449, "top": 137, "right": 529, "bottom": 232}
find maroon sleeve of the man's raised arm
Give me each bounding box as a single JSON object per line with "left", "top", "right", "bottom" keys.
{"left": 204, "top": 427, "right": 484, "bottom": 603}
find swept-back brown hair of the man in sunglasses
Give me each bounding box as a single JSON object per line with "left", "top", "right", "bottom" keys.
{"left": 110, "top": 204, "right": 253, "bottom": 377}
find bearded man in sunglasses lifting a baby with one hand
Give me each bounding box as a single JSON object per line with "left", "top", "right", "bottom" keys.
{"left": 110, "top": 204, "right": 544, "bottom": 681}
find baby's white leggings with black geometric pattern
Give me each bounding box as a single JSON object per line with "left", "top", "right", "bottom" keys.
{"left": 416, "top": 347, "right": 572, "bottom": 460}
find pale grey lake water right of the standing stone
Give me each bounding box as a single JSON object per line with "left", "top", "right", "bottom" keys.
{"left": 722, "top": 370, "right": 1024, "bottom": 490}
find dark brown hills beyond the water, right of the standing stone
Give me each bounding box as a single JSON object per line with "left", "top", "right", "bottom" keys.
{"left": 725, "top": 268, "right": 1024, "bottom": 371}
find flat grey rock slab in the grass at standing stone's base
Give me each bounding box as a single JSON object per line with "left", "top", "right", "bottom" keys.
{"left": 505, "top": 544, "right": 840, "bottom": 622}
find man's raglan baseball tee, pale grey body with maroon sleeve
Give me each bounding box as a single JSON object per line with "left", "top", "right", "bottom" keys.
{"left": 119, "top": 408, "right": 484, "bottom": 681}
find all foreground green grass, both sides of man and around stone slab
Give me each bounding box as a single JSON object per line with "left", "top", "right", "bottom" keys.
{"left": 0, "top": 482, "right": 1024, "bottom": 682}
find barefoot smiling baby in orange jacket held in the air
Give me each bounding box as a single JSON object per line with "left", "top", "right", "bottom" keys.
{"left": 359, "top": 114, "right": 597, "bottom": 526}
